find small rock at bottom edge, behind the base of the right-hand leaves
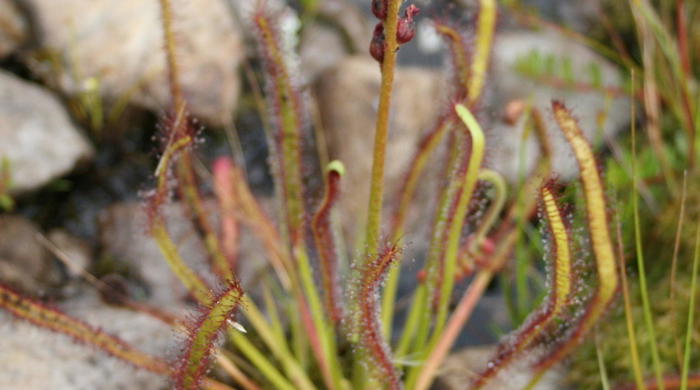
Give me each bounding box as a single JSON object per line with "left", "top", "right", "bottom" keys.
{"left": 431, "top": 346, "right": 567, "bottom": 390}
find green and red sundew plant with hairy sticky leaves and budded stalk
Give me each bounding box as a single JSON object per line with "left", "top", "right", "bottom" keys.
{"left": 0, "top": 0, "right": 697, "bottom": 390}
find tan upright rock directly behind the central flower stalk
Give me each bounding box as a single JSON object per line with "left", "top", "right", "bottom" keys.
{"left": 316, "top": 56, "right": 444, "bottom": 244}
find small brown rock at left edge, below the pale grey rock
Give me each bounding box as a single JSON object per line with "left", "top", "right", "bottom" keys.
{"left": 0, "top": 215, "right": 61, "bottom": 292}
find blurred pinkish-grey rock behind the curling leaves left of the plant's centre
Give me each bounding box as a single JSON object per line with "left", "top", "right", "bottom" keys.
{"left": 99, "top": 203, "right": 266, "bottom": 308}
